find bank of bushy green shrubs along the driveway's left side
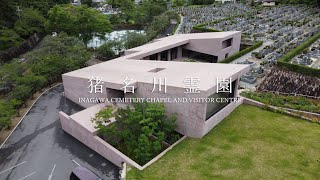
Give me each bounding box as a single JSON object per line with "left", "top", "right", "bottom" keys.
{"left": 0, "top": 32, "right": 90, "bottom": 129}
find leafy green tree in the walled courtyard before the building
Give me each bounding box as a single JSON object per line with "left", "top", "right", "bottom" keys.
{"left": 93, "top": 102, "right": 176, "bottom": 165}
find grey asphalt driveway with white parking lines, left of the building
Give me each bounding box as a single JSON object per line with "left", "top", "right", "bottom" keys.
{"left": 0, "top": 85, "right": 119, "bottom": 180}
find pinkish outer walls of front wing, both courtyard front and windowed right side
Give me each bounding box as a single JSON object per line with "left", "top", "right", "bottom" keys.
{"left": 63, "top": 74, "right": 246, "bottom": 138}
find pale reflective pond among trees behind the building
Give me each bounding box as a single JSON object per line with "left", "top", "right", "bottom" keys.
{"left": 87, "top": 30, "right": 144, "bottom": 48}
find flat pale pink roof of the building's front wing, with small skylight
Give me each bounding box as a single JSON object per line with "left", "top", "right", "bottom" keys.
{"left": 64, "top": 59, "right": 249, "bottom": 91}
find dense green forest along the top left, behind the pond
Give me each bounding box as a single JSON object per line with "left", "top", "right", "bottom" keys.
{"left": 0, "top": 0, "right": 170, "bottom": 51}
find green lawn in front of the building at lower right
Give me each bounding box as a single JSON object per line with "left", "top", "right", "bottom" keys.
{"left": 127, "top": 105, "right": 320, "bottom": 179}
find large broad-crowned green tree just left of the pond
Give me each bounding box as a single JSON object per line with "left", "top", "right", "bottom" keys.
{"left": 46, "top": 5, "right": 111, "bottom": 44}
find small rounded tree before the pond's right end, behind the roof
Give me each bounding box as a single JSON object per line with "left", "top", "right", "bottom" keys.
{"left": 124, "top": 31, "right": 147, "bottom": 49}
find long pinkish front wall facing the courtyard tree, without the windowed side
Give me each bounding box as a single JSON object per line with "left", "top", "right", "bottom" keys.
{"left": 63, "top": 73, "right": 207, "bottom": 138}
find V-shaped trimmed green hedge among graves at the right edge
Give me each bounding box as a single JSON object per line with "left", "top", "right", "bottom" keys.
{"left": 277, "top": 32, "right": 320, "bottom": 78}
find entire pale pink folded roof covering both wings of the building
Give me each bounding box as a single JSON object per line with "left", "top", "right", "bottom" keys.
{"left": 63, "top": 31, "right": 249, "bottom": 91}
